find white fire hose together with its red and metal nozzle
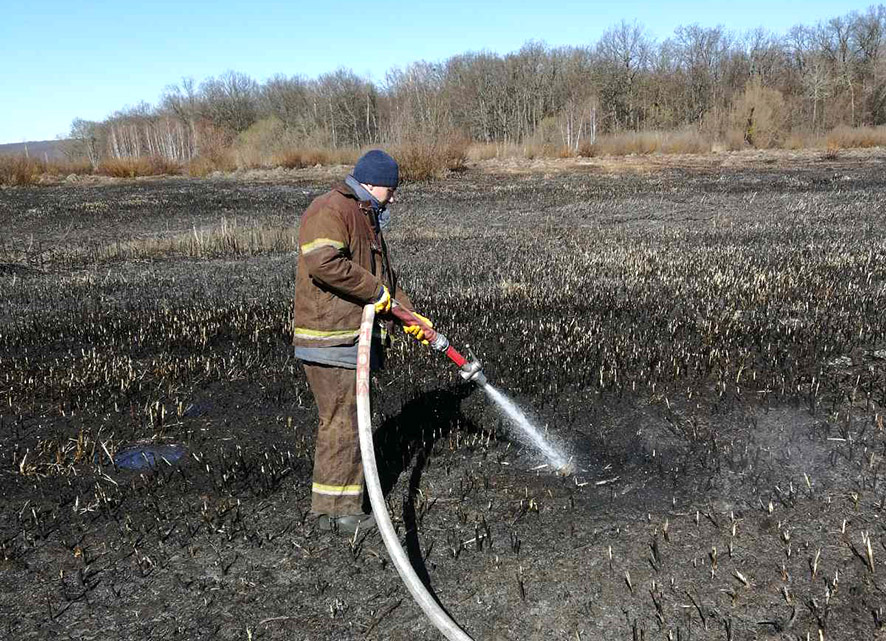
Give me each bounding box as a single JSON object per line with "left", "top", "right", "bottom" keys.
{"left": 357, "top": 302, "right": 486, "bottom": 641}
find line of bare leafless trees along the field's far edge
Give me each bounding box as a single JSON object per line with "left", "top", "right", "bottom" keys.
{"left": 69, "top": 5, "right": 886, "bottom": 165}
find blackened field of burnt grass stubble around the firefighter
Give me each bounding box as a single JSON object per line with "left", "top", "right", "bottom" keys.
{"left": 0, "top": 157, "right": 886, "bottom": 640}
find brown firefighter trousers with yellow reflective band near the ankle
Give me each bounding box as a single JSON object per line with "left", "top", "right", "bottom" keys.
{"left": 303, "top": 363, "right": 363, "bottom": 516}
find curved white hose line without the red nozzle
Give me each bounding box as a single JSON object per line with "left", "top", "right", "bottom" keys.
{"left": 357, "top": 305, "right": 472, "bottom": 641}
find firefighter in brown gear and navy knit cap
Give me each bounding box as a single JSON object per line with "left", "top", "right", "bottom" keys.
{"left": 293, "top": 149, "right": 432, "bottom": 534}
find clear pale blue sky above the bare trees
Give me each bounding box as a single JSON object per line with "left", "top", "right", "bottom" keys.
{"left": 0, "top": 0, "right": 875, "bottom": 143}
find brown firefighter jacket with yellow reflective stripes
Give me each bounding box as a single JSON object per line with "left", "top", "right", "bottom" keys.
{"left": 293, "top": 183, "right": 412, "bottom": 363}
